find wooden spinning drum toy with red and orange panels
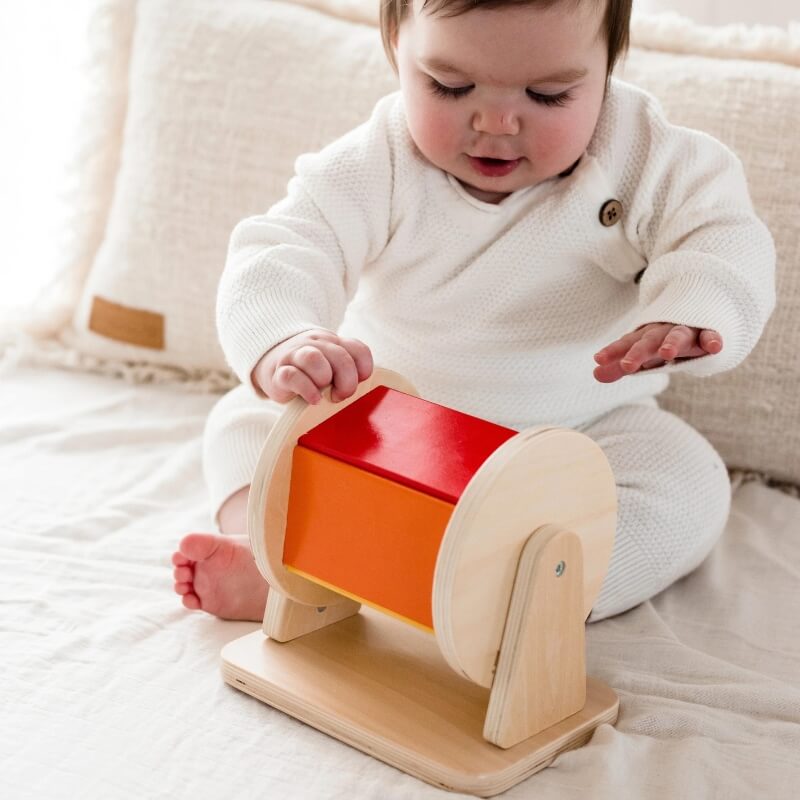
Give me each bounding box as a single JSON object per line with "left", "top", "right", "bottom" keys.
{"left": 222, "top": 369, "right": 619, "bottom": 797}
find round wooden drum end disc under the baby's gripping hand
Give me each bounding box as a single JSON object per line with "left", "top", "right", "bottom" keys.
{"left": 247, "top": 368, "right": 419, "bottom": 606}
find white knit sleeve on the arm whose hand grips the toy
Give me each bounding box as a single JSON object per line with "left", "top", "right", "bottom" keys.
{"left": 216, "top": 98, "right": 392, "bottom": 382}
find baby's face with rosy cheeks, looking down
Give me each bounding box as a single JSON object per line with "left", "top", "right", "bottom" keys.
{"left": 395, "top": 0, "right": 607, "bottom": 203}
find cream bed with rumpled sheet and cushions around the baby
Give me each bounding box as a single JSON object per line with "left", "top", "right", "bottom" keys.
{"left": 0, "top": 0, "right": 800, "bottom": 800}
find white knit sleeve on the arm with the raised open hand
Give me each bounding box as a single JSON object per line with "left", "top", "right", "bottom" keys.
{"left": 608, "top": 84, "right": 775, "bottom": 376}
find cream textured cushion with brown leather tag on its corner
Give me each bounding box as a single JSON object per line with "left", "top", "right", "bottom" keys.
{"left": 62, "top": 0, "right": 397, "bottom": 370}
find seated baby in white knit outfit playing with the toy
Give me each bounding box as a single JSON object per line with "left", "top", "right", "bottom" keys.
{"left": 173, "top": 0, "right": 775, "bottom": 622}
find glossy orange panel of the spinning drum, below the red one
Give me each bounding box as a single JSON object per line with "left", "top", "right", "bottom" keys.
{"left": 283, "top": 445, "right": 454, "bottom": 630}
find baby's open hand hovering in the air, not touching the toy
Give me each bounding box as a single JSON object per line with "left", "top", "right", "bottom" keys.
{"left": 594, "top": 322, "right": 722, "bottom": 383}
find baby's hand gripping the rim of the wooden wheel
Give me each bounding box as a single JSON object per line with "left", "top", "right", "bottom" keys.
{"left": 251, "top": 329, "right": 373, "bottom": 405}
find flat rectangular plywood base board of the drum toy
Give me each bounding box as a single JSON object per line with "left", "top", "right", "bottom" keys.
{"left": 222, "top": 608, "right": 619, "bottom": 797}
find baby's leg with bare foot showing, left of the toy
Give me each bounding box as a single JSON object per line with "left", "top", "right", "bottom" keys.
{"left": 172, "top": 386, "right": 280, "bottom": 621}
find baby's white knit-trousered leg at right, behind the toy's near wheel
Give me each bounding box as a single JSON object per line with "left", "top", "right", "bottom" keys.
{"left": 579, "top": 402, "right": 731, "bottom": 622}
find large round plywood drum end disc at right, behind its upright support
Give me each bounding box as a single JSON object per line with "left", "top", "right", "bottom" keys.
{"left": 433, "top": 427, "right": 617, "bottom": 688}
